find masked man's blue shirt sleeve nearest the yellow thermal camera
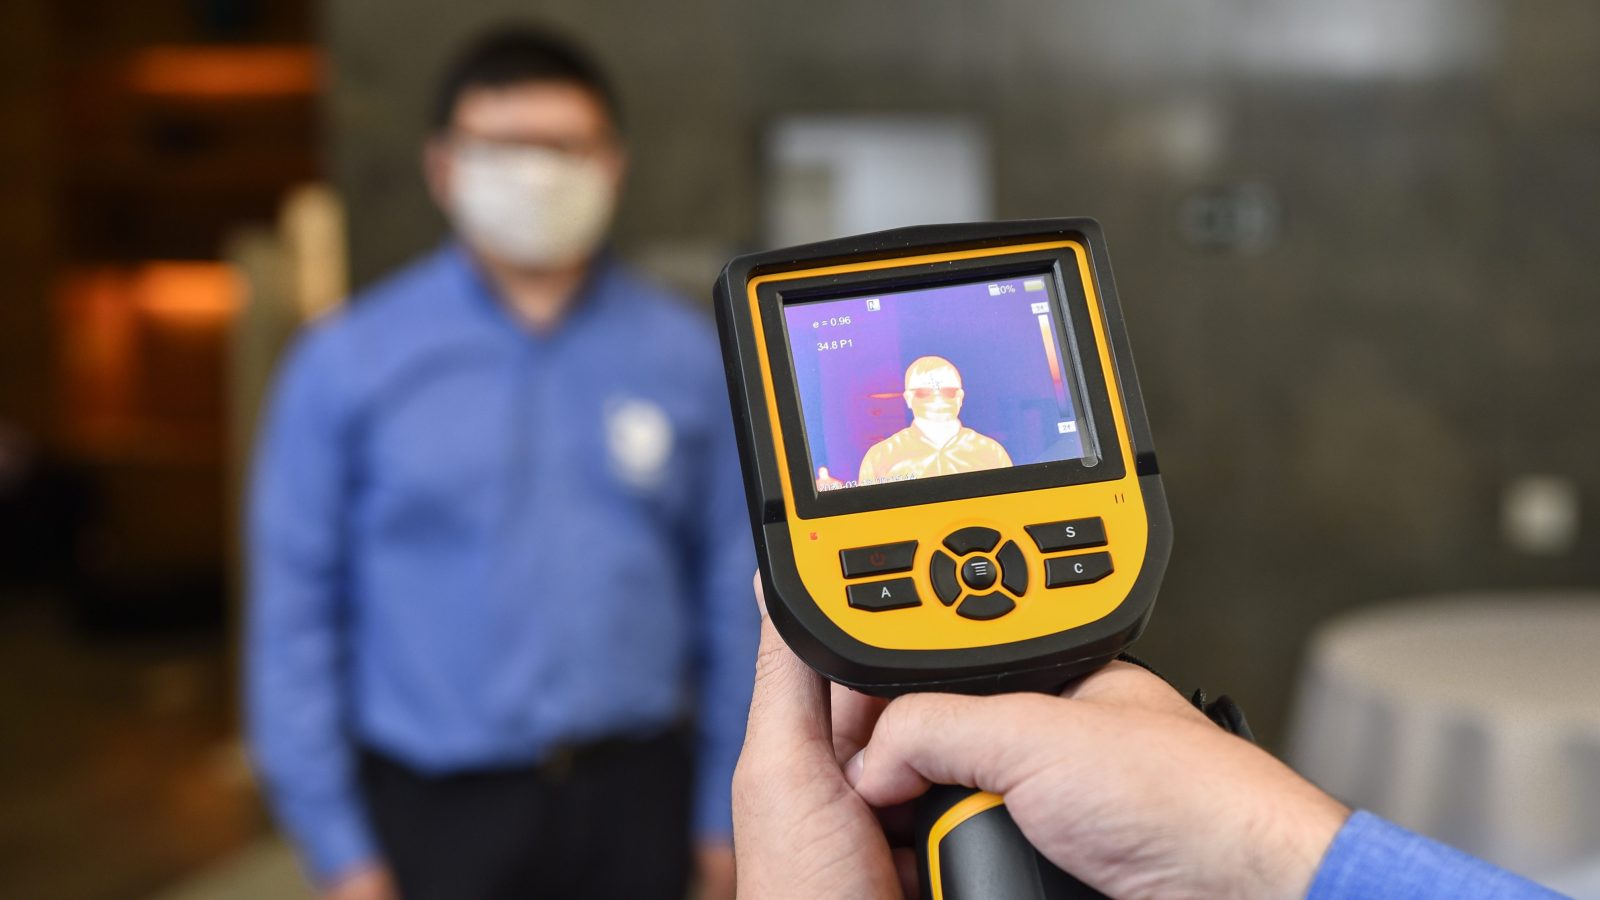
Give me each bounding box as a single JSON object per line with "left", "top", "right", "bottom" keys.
{"left": 694, "top": 368, "right": 760, "bottom": 842}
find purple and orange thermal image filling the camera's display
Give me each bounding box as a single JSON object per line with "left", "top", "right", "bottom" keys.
{"left": 784, "top": 275, "right": 1085, "bottom": 492}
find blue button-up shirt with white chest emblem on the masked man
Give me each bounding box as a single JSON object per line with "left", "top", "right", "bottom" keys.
{"left": 248, "top": 247, "right": 758, "bottom": 878}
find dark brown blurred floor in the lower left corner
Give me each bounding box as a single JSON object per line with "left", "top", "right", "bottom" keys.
{"left": 0, "top": 591, "right": 267, "bottom": 900}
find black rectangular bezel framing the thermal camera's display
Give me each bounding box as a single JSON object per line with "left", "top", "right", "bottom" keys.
{"left": 755, "top": 247, "right": 1126, "bottom": 519}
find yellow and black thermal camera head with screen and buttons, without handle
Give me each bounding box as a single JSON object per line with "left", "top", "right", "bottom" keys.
{"left": 715, "top": 218, "right": 1171, "bottom": 695}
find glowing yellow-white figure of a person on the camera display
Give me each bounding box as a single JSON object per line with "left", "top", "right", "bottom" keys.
{"left": 858, "top": 356, "right": 1011, "bottom": 484}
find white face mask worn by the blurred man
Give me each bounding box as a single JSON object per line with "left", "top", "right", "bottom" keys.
{"left": 450, "top": 143, "right": 616, "bottom": 267}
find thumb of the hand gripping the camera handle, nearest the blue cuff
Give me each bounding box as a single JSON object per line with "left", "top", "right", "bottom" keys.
{"left": 845, "top": 693, "right": 1074, "bottom": 807}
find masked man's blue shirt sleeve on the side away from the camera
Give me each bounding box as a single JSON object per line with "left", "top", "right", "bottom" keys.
{"left": 245, "top": 330, "right": 376, "bottom": 881}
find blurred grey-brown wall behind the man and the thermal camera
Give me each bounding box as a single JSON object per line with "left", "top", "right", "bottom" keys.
{"left": 325, "top": 0, "right": 1600, "bottom": 740}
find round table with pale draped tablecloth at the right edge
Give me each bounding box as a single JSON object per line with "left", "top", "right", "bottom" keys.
{"left": 1288, "top": 591, "right": 1600, "bottom": 890}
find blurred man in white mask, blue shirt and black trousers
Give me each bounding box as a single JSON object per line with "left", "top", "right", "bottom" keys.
{"left": 248, "top": 30, "right": 757, "bottom": 900}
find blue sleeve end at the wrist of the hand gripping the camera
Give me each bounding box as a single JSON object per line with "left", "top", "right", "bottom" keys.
{"left": 1306, "top": 810, "right": 1562, "bottom": 900}
